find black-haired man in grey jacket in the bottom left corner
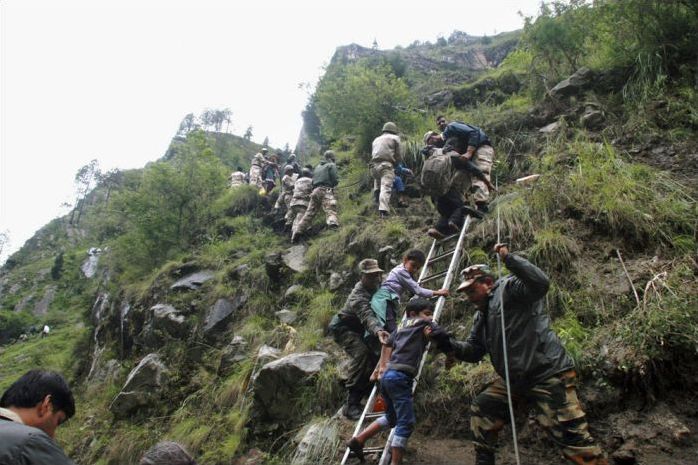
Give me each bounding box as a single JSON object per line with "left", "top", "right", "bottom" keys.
{"left": 0, "top": 370, "right": 75, "bottom": 465}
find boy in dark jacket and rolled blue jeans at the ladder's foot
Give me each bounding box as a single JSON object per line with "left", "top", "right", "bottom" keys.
{"left": 347, "top": 299, "right": 451, "bottom": 465}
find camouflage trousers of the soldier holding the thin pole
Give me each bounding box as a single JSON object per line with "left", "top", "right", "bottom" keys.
{"left": 470, "top": 371, "right": 608, "bottom": 465}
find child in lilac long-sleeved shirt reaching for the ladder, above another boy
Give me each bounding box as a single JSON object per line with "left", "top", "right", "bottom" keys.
{"left": 371, "top": 249, "right": 448, "bottom": 380}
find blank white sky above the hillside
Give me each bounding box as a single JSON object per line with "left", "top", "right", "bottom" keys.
{"left": 0, "top": 0, "right": 540, "bottom": 263}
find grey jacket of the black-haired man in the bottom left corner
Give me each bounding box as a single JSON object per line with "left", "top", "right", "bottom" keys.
{"left": 0, "top": 418, "right": 75, "bottom": 465}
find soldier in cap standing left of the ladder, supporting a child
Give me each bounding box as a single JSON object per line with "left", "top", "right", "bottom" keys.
{"left": 329, "top": 258, "right": 390, "bottom": 420}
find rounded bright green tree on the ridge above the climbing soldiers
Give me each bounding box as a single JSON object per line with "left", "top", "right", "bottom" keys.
{"left": 314, "top": 61, "right": 415, "bottom": 152}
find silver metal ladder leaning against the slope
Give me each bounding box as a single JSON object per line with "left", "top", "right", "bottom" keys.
{"left": 341, "top": 211, "right": 472, "bottom": 465}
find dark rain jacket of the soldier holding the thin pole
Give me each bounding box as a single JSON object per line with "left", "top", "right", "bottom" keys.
{"left": 451, "top": 254, "right": 574, "bottom": 390}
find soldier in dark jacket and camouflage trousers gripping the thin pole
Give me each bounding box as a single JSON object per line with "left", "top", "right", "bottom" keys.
{"left": 447, "top": 244, "right": 608, "bottom": 465}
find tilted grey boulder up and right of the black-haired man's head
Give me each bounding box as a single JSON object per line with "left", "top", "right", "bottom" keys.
{"left": 109, "top": 353, "right": 168, "bottom": 417}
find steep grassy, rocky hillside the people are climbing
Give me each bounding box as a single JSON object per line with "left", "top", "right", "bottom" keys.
{"left": 0, "top": 5, "right": 698, "bottom": 465}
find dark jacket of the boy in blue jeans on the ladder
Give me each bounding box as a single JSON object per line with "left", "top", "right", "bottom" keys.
{"left": 388, "top": 318, "right": 451, "bottom": 376}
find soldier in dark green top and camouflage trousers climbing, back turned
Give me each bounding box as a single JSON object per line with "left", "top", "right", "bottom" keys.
{"left": 291, "top": 150, "right": 339, "bottom": 242}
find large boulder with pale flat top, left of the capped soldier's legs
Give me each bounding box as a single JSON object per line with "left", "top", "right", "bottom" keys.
{"left": 253, "top": 352, "right": 328, "bottom": 423}
